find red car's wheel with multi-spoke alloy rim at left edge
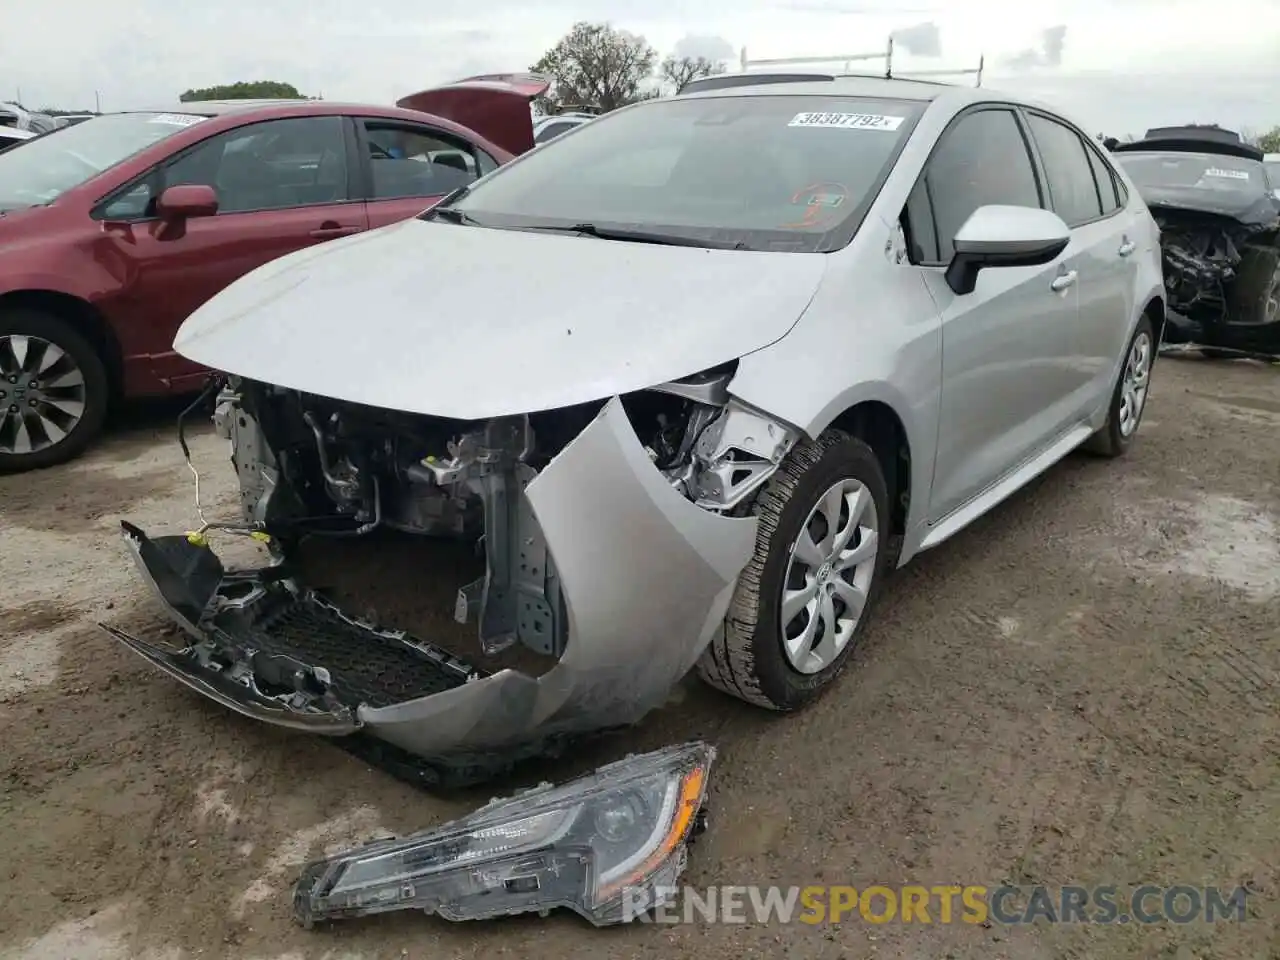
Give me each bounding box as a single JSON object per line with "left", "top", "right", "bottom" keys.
{"left": 0, "top": 308, "right": 110, "bottom": 474}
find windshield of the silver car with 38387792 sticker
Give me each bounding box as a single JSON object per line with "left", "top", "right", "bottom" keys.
{"left": 440, "top": 96, "right": 922, "bottom": 251}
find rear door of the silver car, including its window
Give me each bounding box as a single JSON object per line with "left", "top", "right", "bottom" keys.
{"left": 1027, "top": 110, "right": 1140, "bottom": 417}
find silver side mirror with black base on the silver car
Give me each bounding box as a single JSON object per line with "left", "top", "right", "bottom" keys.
{"left": 946, "top": 204, "right": 1071, "bottom": 296}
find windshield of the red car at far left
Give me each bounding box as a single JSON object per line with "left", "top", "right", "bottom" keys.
{"left": 0, "top": 114, "right": 205, "bottom": 211}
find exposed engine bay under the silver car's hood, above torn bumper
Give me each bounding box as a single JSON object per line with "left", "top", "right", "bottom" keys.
{"left": 221, "top": 364, "right": 796, "bottom": 657}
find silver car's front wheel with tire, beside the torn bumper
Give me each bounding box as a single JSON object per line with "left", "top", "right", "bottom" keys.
{"left": 698, "top": 430, "right": 892, "bottom": 712}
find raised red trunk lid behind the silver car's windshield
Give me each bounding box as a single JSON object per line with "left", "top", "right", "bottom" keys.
{"left": 396, "top": 73, "right": 552, "bottom": 155}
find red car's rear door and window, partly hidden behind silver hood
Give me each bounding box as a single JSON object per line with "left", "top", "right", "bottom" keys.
{"left": 357, "top": 118, "right": 498, "bottom": 227}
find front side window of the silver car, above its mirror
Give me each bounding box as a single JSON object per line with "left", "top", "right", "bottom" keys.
{"left": 909, "top": 109, "right": 1039, "bottom": 262}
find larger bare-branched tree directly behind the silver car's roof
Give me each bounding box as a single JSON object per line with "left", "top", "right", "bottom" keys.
{"left": 530, "top": 20, "right": 658, "bottom": 113}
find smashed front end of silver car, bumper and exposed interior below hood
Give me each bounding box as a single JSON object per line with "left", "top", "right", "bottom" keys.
{"left": 110, "top": 365, "right": 796, "bottom": 782}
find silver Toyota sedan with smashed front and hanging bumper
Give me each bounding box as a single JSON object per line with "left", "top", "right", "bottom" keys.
{"left": 114, "top": 73, "right": 1164, "bottom": 783}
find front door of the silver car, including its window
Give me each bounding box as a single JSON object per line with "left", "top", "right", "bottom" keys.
{"left": 906, "top": 105, "right": 1079, "bottom": 522}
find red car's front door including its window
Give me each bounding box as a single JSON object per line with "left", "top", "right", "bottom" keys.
{"left": 95, "top": 116, "right": 369, "bottom": 390}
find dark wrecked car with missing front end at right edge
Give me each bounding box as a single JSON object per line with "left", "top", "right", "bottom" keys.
{"left": 1112, "top": 127, "right": 1280, "bottom": 357}
